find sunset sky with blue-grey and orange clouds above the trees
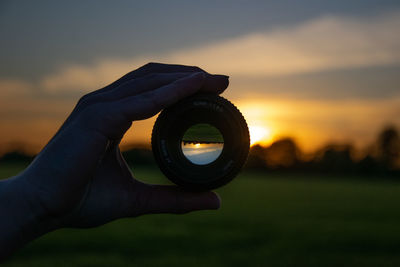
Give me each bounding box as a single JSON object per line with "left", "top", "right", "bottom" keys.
{"left": 0, "top": 0, "right": 400, "bottom": 153}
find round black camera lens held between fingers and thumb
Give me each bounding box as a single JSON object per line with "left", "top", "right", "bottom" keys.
{"left": 151, "top": 94, "right": 250, "bottom": 191}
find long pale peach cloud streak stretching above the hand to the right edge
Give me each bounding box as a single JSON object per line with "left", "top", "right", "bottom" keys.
{"left": 39, "top": 12, "right": 400, "bottom": 92}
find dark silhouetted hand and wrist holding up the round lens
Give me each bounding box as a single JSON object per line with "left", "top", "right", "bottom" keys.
{"left": 0, "top": 63, "right": 228, "bottom": 258}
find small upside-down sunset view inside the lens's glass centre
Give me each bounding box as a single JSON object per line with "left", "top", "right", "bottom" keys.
{"left": 181, "top": 123, "right": 224, "bottom": 165}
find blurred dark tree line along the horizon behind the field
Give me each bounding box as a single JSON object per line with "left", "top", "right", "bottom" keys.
{"left": 0, "top": 126, "right": 400, "bottom": 178}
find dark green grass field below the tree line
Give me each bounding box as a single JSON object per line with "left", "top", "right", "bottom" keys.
{"left": 0, "top": 166, "right": 400, "bottom": 266}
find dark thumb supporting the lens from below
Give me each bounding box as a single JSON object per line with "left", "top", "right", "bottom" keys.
{"left": 138, "top": 185, "right": 221, "bottom": 214}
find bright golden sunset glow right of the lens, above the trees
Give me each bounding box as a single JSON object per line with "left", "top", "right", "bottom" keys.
{"left": 235, "top": 95, "right": 400, "bottom": 153}
